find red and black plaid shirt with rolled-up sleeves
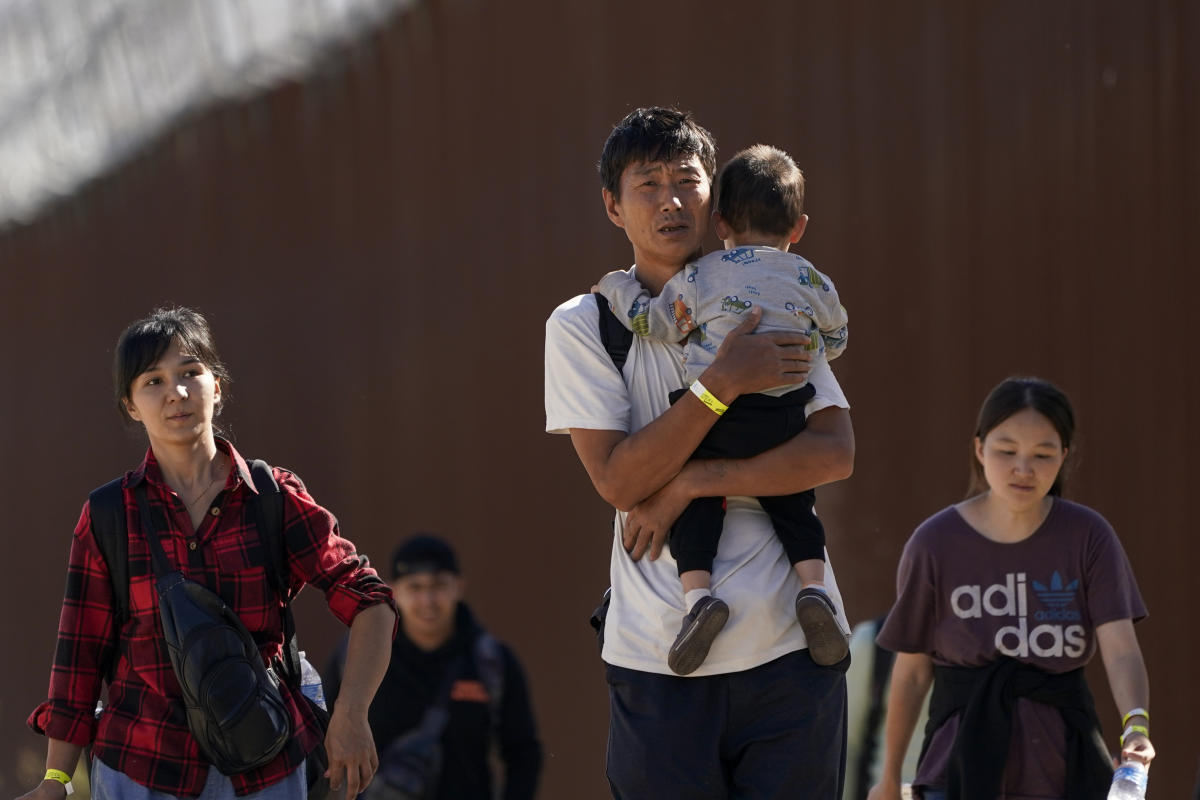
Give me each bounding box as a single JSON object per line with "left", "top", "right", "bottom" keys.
{"left": 29, "top": 439, "right": 395, "bottom": 796}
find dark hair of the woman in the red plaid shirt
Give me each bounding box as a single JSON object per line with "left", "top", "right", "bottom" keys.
{"left": 113, "top": 306, "right": 232, "bottom": 422}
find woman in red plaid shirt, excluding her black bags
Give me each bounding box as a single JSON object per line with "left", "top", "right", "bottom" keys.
{"left": 20, "top": 308, "right": 396, "bottom": 800}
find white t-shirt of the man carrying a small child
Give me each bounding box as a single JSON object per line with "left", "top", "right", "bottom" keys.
{"left": 546, "top": 287, "right": 850, "bottom": 676}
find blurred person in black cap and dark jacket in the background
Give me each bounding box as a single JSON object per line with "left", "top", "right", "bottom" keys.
{"left": 326, "top": 534, "right": 541, "bottom": 800}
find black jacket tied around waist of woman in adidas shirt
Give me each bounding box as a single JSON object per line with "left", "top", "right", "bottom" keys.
{"left": 922, "top": 657, "right": 1112, "bottom": 800}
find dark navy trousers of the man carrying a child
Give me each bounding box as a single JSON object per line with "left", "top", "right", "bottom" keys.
{"left": 606, "top": 650, "right": 848, "bottom": 800}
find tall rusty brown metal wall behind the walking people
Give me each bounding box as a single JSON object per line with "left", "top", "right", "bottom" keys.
{"left": 0, "top": 0, "right": 1200, "bottom": 799}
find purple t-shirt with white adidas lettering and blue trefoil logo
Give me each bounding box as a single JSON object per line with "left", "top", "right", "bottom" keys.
{"left": 877, "top": 498, "right": 1146, "bottom": 800}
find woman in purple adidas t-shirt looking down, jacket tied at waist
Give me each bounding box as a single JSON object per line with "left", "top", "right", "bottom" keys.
{"left": 870, "top": 378, "right": 1154, "bottom": 800}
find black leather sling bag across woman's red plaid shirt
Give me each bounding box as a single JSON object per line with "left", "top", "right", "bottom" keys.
{"left": 137, "top": 483, "right": 292, "bottom": 775}
